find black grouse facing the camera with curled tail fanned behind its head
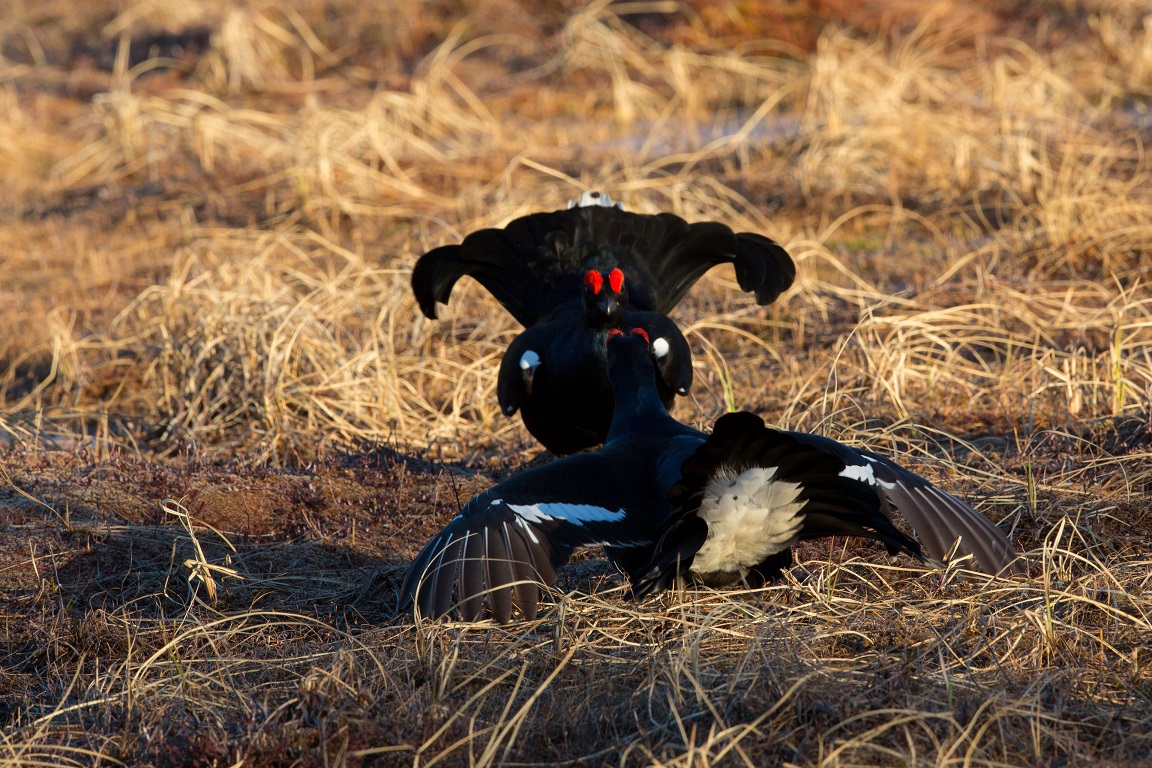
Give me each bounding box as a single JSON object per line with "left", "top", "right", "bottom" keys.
{"left": 412, "top": 192, "right": 796, "bottom": 455}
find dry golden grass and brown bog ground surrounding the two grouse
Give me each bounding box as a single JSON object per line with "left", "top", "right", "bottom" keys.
{"left": 0, "top": 0, "right": 1152, "bottom": 767}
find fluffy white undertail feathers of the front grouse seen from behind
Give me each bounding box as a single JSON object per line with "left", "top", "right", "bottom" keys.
{"left": 692, "top": 466, "right": 808, "bottom": 578}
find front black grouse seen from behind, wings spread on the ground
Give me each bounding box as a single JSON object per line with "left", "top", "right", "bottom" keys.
{"left": 400, "top": 330, "right": 1018, "bottom": 622}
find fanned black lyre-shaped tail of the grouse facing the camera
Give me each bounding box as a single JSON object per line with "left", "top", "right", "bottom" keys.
{"left": 412, "top": 193, "right": 796, "bottom": 328}
